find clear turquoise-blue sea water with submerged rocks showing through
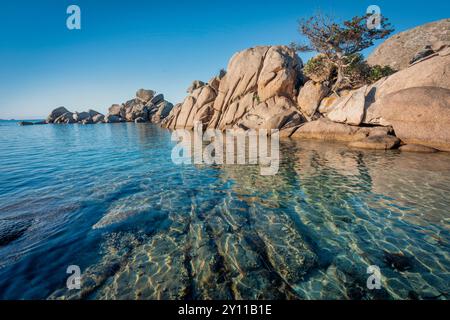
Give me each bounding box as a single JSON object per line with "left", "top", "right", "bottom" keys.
{"left": 0, "top": 122, "right": 450, "bottom": 299}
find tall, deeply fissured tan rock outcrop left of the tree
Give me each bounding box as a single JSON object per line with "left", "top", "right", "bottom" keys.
{"left": 164, "top": 46, "right": 304, "bottom": 130}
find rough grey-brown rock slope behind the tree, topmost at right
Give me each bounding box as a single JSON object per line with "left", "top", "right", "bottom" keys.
{"left": 367, "top": 19, "right": 450, "bottom": 70}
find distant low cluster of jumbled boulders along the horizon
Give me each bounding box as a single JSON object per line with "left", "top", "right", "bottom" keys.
{"left": 44, "top": 89, "right": 173, "bottom": 125}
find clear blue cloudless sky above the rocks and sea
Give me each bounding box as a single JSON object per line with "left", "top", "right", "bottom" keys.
{"left": 0, "top": 0, "right": 450, "bottom": 119}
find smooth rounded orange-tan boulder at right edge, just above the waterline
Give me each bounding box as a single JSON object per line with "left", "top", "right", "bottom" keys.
{"left": 362, "top": 87, "right": 450, "bottom": 151}
